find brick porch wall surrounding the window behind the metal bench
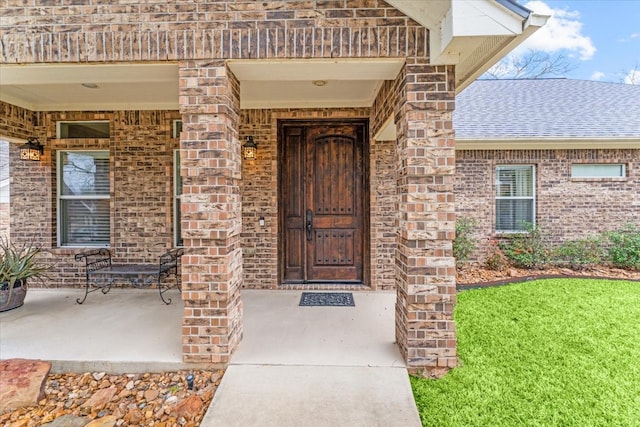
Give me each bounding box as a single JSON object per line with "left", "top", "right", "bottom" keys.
{"left": 0, "top": 107, "right": 180, "bottom": 287}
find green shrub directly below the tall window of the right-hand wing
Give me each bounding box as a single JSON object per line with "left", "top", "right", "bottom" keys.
{"left": 500, "top": 222, "right": 549, "bottom": 268}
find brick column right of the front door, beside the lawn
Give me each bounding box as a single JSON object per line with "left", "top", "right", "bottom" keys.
{"left": 395, "top": 60, "right": 457, "bottom": 371}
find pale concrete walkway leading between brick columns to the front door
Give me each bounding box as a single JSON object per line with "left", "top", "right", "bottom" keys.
{"left": 201, "top": 291, "right": 420, "bottom": 427}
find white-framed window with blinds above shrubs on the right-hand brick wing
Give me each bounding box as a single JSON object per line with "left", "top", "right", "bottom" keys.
{"left": 496, "top": 165, "right": 535, "bottom": 232}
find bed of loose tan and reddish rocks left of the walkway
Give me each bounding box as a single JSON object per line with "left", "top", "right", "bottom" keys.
{"left": 0, "top": 370, "right": 224, "bottom": 427}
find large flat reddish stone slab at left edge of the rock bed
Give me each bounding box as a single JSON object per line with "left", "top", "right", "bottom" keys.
{"left": 0, "top": 359, "right": 51, "bottom": 414}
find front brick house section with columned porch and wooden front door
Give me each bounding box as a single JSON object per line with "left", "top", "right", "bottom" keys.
{"left": 0, "top": 0, "right": 546, "bottom": 368}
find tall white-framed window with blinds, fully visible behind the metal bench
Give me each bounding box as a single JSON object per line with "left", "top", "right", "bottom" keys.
{"left": 58, "top": 151, "right": 111, "bottom": 246}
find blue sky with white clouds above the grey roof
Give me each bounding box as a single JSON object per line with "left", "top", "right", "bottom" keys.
{"left": 500, "top": 0, "right": 640, "bottom": 84}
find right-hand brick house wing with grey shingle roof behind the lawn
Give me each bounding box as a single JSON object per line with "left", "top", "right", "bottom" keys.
{"left": 454, "top": 79, "right": 640, "bottom": 260}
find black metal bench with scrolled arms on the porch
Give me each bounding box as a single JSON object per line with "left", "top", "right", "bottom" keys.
{"left": 75, "top": 248, "right": 184, "bottom": 304}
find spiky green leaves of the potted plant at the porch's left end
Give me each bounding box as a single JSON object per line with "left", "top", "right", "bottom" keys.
{"left": 0, "top": 238, "right": 51, "bottom": 289}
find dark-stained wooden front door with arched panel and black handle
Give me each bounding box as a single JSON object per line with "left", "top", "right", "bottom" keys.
{"left": 280, "top": 122, "right": 367, "bottom": 283}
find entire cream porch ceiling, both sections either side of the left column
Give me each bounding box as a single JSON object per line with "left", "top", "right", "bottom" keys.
{"left": 0, "top": 59, "right": 404, "bottom": 111}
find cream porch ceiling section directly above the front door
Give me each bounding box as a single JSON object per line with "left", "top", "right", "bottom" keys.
{"left": 227, "top": 58, "right": 405, "bottom": 109}
